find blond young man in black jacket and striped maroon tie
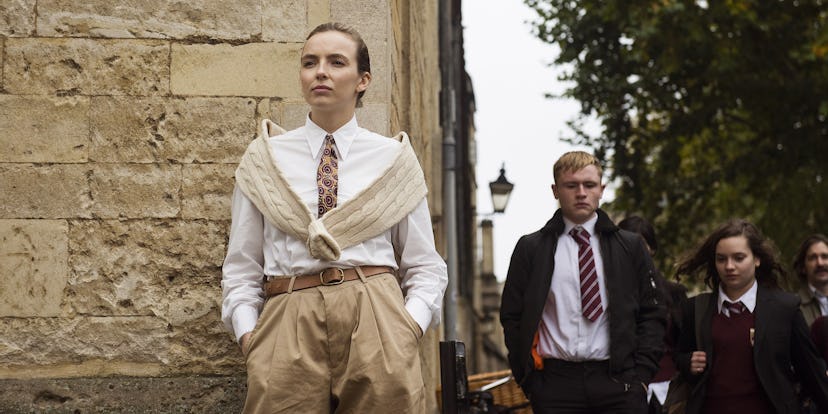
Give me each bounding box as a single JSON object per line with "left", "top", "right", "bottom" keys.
{"left": 500, "top": 151, "right": 665, "bottom": 414}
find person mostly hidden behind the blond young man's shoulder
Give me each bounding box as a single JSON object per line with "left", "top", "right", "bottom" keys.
{"left": 618, "top": 216, "right": 687, "bottom": 414}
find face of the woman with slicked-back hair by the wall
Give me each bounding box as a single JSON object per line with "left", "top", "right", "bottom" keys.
{"left": 299, "top": 30, "right": 371, "bottom": 113}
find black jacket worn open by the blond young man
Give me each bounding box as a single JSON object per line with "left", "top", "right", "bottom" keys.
{"left": 500, "top": 209, "right": 666, "bottom": 386}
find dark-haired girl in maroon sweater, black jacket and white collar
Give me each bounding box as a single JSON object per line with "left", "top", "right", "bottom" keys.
{"left": 676, "top": 220, "right": 828, "bottom": 414}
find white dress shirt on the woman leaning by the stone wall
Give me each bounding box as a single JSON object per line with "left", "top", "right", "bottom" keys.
{"left": 222, "top": 117, "right": 448, "bottom": 339}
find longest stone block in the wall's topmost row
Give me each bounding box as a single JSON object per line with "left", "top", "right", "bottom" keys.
{"left": 37, "top": 0, "right": 262, "bottom": 40}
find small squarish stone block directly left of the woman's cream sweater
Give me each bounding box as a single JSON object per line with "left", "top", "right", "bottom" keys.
{"left": 181, "top": 163, "right": 234, "bottom": 220}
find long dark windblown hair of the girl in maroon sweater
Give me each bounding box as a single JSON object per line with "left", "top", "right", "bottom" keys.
{"left": 676, "top": 219, "right": 785, "bottom": 291}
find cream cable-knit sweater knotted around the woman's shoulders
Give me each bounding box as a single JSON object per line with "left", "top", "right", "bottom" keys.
{"left": 236, "top": 119, "right": 427, "bottom": 261}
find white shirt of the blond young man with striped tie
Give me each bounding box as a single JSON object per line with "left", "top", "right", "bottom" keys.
{"left": 538, "top": 214, "right": 610, "bottom": 361}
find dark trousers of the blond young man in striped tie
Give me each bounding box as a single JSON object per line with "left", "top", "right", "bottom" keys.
{"left": 526, "top": 359, "right": 647, "bottom": 414}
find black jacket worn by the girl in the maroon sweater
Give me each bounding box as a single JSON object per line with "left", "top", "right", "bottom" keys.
{"left": 676, "top": 285, "right": 828, "bottom": 414}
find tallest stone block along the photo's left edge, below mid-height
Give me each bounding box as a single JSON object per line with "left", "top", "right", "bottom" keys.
{"left": 0, "top": 220, "right": 69, "bottom": 317}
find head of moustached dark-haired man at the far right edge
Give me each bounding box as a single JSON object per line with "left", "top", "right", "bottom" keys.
{"left": 793, "top": 234, "right": 828, "bottom": 326}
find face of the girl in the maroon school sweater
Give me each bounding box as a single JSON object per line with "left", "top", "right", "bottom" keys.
{"left": 715, "top": 236, "right": 759, "bottom": 299}
